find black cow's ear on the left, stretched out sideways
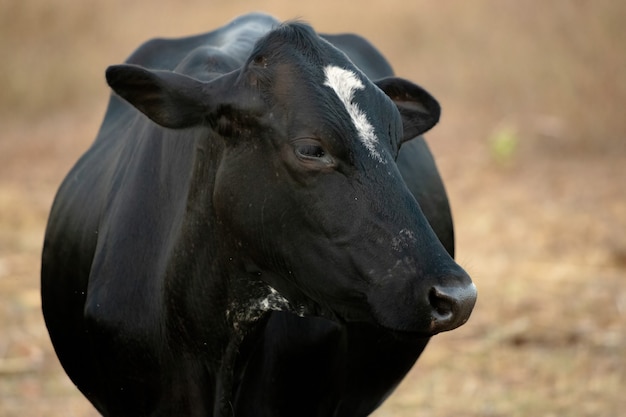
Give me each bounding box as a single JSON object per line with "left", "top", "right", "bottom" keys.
{"left": 106, "top": 64, "right": 207, "bottom": 129}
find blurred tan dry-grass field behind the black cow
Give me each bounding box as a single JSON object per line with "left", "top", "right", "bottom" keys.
{"left": 0, "top": 0, "right": 626, "bottom": 417}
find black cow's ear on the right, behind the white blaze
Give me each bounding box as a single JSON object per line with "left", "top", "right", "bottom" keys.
{"left": 376, "top": 77, "right": 441, "bottom": 142}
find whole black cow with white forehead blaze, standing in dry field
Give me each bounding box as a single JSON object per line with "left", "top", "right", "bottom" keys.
{"left": 42, "top": 14, "right": 476, "bottom": 417}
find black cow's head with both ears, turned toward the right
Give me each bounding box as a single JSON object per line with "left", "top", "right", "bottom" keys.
{"left": 107, "top": 24, "right": 476, "bottom": 335}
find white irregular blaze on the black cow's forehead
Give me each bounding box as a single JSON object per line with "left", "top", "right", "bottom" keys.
{"left": 324, "top": 65, "right": 385, "bottom": 164}
